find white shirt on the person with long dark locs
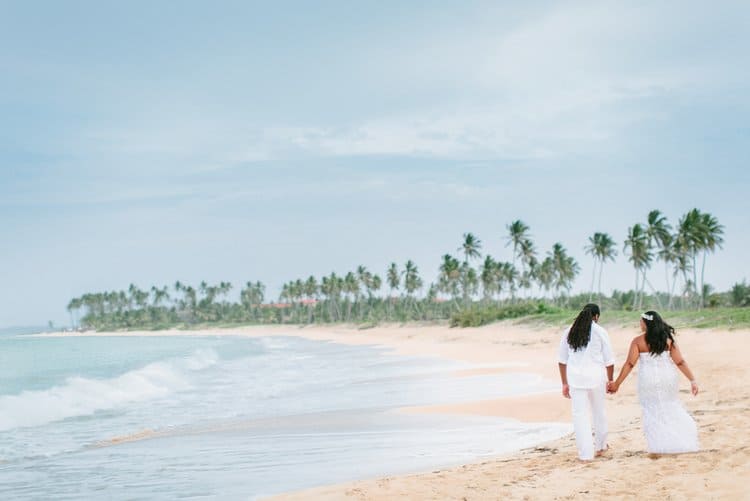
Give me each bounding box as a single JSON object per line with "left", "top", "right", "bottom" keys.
{"left": 558, "top": 322, "right": 615, "bottom": 388}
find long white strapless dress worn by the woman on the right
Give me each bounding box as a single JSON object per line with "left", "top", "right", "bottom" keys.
{"left": 638, "top": 351, "right": 699, "bottom": 454}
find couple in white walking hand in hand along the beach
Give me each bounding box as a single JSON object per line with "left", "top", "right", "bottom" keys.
{"left": 558, "top": 304, "right": 698, "bottom": 461}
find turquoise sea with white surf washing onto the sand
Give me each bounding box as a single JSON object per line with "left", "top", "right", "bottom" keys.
{"left": 0, "top": 330, "right": 568, "bottom": 499}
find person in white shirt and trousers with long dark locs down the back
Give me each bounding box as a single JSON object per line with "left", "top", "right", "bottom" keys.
{"left": 558, "top": 304, "right": 615, "bottom": 461}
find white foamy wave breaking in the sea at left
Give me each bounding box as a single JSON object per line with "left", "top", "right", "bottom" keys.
{"left": 0, "top": 350, "right": 218, "bottom": 431}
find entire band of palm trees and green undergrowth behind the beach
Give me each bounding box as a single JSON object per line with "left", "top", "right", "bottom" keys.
{"left": 68, "top": 209, "right": 750, "bottom": 330}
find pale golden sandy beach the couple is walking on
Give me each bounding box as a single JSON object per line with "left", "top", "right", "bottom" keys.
{"left": 32, "top": 319, "right": 750, "bottom": 500}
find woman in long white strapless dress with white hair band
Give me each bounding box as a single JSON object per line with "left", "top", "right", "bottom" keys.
{"left": 607, "top": 311, "right": 699, "bottom": 454}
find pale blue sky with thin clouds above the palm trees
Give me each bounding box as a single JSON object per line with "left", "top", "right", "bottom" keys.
{"left": 0, "top": 0, "right": 750, "bottom": 326}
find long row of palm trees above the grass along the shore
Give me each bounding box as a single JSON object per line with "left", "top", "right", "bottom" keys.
{"left": 68, "top": 209, "right": 723, "bottom": 327}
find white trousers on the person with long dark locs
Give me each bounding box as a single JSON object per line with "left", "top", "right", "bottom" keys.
{"left": 570, "top": 385, "right": 607, "bottom": 461}
